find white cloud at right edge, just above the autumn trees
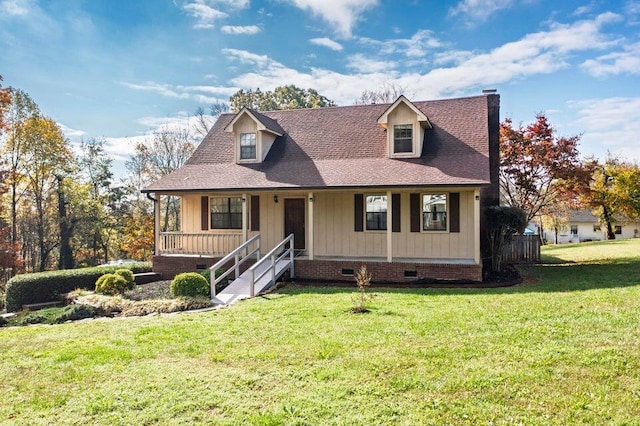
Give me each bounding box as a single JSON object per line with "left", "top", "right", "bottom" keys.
{"left": 569, "top": 97, "right": 640, "bottom": 161}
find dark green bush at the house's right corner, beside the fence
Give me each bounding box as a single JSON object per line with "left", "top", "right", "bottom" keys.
{"left": 485, "top": 206, "right": 527, "bottom": 272}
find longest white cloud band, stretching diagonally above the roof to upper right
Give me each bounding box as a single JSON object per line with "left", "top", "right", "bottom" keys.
{"left": 223, "top": 14, "right": 619, "bottom": 104}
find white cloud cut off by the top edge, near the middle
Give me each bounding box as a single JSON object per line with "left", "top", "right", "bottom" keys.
{"left": 286, "top": 0, "right": 378, "bottom": 37}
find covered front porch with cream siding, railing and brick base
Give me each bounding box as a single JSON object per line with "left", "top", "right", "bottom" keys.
{"left": 154, "top": 188, "right": 482, "bottom": 282}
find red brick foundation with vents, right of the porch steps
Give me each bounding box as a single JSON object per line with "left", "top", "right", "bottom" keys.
{"left": 295, "top": 259, "right": 482, "bottom": 283}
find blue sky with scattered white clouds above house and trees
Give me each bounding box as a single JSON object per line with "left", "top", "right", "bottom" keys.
{"left": 0, "top": 0, "right": 640, "bottom": 177}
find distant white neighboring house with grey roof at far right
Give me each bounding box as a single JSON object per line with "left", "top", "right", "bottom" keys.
{"left": 545, "top": 210, "right": 640, "bottom": 244}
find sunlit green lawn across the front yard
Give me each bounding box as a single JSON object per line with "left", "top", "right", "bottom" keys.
{"left": 0, "top": 240, "right": 640, "bottom": 425}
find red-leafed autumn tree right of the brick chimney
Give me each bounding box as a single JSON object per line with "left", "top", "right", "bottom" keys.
{"left": 500, "top": 114, "right": 592, "bottom": 225}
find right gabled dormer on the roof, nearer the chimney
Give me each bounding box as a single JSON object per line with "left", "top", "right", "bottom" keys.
{"left": 378, "top": 95, "right": 431, "bottom": 158}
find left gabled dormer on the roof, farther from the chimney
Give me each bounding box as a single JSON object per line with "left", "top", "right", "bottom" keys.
{"left": 224, "top": 107, "right": 284, "bottom": 164}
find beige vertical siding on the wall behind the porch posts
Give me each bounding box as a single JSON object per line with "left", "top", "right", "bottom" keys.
{"left": 175, "top": 190, "right": 474, "bottom": 259}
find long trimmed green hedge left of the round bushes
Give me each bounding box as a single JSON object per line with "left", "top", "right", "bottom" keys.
{"left": 6, "top": 262, "right": 151, "bottom": 312}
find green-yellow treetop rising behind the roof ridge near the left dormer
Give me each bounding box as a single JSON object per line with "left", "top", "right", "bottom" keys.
{"left": 229, "top": 85, "right": 335, "bottom": 112}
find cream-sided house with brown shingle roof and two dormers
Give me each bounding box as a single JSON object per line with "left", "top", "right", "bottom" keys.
{"left": 143, "top": 91, "right": 500, "bottom": 282}
